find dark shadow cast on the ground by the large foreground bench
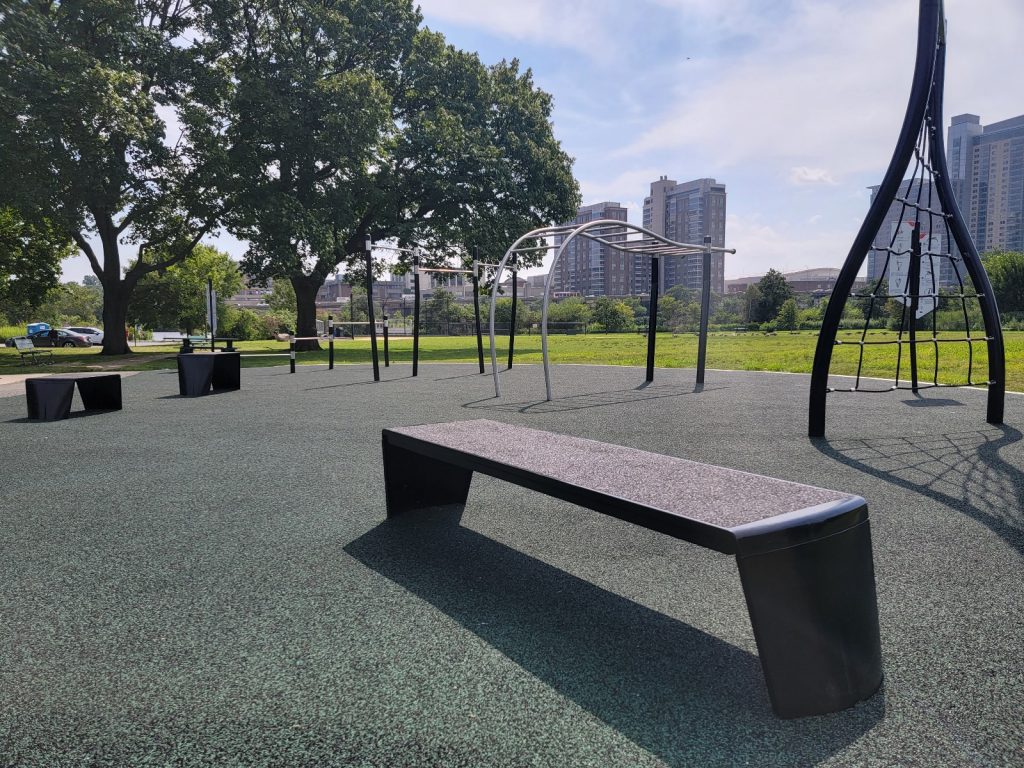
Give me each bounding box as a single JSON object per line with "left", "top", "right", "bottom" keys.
{"left": 344, "top": 507, "right": 885, "bottom": 766}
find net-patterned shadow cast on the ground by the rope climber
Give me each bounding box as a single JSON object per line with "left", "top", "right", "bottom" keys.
{"left": 812, "top": 428, "right": 1024, "bottom": 555}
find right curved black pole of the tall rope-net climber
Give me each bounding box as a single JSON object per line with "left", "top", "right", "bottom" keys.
{"left": 928, "top": 19, "right": 1007, "bottom": 424}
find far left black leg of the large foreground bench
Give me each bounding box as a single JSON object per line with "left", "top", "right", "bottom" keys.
{"left": 383, "top": 436, "right": 473, "bottom": 517}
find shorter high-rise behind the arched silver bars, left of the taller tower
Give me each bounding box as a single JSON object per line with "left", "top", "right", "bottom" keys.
{"left": 552, "top": 202, "right": 633, "bottom": 296}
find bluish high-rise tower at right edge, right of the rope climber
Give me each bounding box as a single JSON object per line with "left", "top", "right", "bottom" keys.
{"left": 946, "top": 115, "right": 1024, "bottom": 253}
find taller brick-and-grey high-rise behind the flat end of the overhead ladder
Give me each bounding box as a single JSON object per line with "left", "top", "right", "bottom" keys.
{"left": 633, "top": 176, "right": 725, "bottom": 293}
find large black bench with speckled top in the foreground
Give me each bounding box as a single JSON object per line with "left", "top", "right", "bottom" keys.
{"left": 382, "top": 420, "right": 882, "bottom": 718}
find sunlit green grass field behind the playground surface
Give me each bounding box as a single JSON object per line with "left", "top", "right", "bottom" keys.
{"left": 0, "top": 331, "right": 1024, "bottom": 391}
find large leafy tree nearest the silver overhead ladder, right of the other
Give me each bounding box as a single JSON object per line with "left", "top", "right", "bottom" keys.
{"left": 209, "top": 0, "right": 579, "bottom": 344}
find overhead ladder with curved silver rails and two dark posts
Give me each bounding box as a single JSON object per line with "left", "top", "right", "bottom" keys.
{"left": 490, "top": 219, "right": 736, "bottom": 400}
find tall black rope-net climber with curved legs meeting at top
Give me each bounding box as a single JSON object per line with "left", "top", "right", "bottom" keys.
{"left": 808, "top": 0, "right": 1006, "bottom": 437}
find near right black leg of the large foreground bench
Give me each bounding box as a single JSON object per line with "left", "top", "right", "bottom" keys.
{"left": 736, "top": 520, "right": 882, "bottom": 718}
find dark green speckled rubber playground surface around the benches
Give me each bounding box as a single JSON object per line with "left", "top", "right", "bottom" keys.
{"left": 0, "top": 365, "right": 1024, "bottom": 768}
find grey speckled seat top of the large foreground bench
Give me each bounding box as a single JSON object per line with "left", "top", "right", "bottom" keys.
{"left": 387, "top": 419, "right": 862, "bottom": 529}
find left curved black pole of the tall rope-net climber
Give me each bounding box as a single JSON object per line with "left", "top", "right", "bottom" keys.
{"left": 807, "top": 0, "right": 951, "bottom": 437}
